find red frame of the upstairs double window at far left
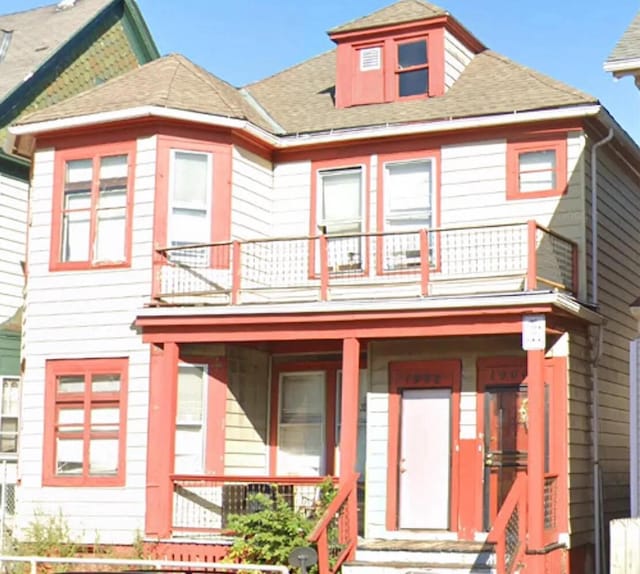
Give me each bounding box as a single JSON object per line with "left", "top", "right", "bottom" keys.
{"left": 49, "top": 141, "right": 136, "bottom": 271}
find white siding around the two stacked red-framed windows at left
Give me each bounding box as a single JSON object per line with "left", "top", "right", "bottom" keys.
{"left": 18, "top": 137, "right": 156, "bottom": 544}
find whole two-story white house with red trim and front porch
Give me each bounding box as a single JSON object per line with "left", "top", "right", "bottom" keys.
{"left": 12, "top": 0, "right": 640, "bottom": 574}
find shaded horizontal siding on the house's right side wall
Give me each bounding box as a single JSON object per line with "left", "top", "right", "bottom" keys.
{"left": 585, "top": 137, "right": 640, "bottom": 544}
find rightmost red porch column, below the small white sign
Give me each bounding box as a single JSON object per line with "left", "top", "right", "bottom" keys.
{"left": 527, "top": 350, "right": 545, "bottom": 558}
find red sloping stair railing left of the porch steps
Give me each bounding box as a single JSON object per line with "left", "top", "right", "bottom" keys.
{"left": 308, "top": 474, "right": 358, "bottom": 574}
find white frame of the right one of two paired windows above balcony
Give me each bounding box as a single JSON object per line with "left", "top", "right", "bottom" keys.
{"left": 381, "top": 156, "right": 438, "bottom": 270}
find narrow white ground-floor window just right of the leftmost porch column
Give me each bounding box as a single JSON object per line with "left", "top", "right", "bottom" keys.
{"left": 174, "top": 365, "right": 207, "bottom": 474}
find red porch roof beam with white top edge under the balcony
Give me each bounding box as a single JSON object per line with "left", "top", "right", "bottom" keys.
{"left": 135, "top": 292, "right": 602, "bottom": 343}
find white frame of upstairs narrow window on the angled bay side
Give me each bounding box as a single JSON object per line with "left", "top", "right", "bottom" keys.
{"left": 167, "top": 148, "right": 214, "bottom": 266}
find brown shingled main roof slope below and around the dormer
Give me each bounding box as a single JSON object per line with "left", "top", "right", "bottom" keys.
{"left": 247, "top": 50, "right": 597, "bottom": 133}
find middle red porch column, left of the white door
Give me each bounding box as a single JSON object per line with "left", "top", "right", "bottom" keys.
{"left": 340, "top": 339, "right": 360, "bottom": 482}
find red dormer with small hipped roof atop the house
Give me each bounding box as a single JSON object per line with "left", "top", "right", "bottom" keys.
{"left": 329, "top": 0, "right": 484, "bottom": 108}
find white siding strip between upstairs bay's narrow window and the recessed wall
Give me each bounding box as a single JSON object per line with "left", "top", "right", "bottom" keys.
{"left": 232, "top": 146, "right": 273, "bottom": 239}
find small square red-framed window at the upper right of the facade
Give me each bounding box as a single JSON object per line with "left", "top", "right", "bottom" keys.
{"left": 507, "top": 137, "right": 567, "bottom": 199}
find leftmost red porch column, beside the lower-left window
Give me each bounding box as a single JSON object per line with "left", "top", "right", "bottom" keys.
{"left": 145, "top": 343, "right": 178, "bottom": 538}
